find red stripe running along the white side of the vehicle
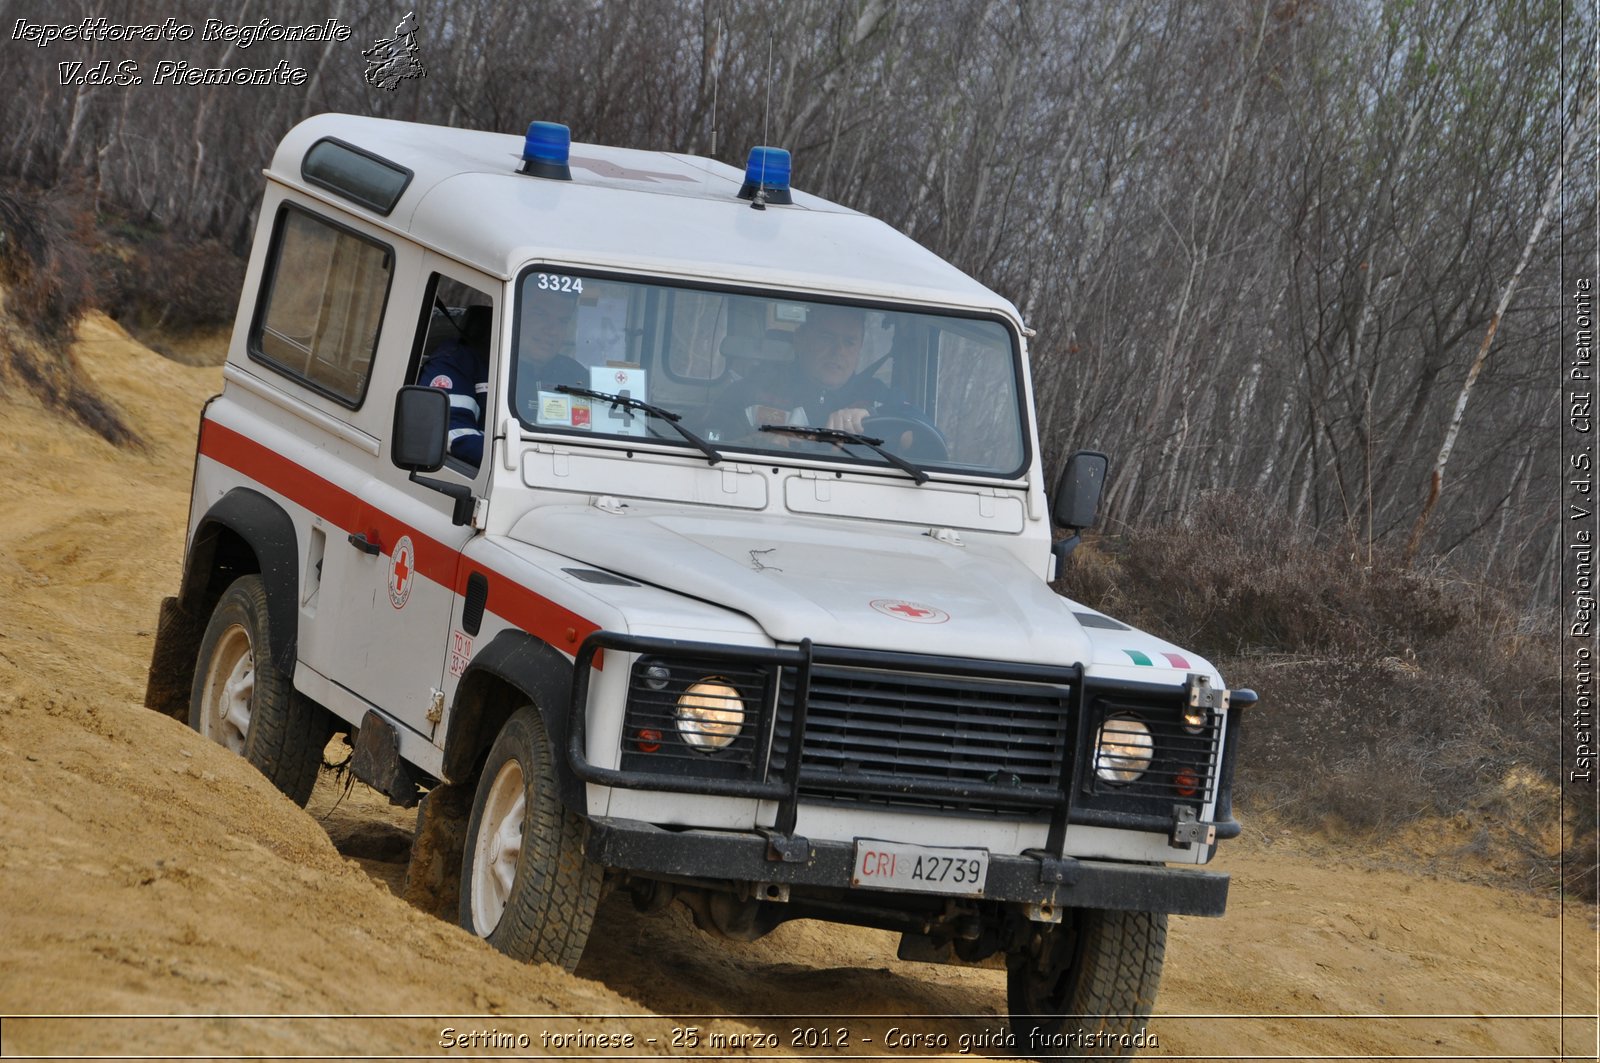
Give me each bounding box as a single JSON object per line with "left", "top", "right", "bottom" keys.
{"left": 200, "top": 421, "right": 600, "bottom": 668}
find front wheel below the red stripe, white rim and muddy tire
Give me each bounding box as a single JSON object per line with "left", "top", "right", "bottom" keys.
{"left": 461, "top": 708, "right": 602, "bottom": 970}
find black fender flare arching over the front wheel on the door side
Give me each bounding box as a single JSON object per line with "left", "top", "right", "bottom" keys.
{"left": 440, "top": 631, "right": 587, "bottom": 815}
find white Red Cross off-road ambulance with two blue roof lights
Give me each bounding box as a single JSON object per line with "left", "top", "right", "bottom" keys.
{"left": 147, "top": 115, "right": 1254, "bottom": 1053}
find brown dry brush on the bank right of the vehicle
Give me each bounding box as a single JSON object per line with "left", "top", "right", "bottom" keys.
{"left": 1062, "top": 496, "right": 1568, "bottom": 882}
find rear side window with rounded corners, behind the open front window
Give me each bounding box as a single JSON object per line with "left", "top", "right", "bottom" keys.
{"left": 250, "top": 207, "right": 394, "bottom": 408}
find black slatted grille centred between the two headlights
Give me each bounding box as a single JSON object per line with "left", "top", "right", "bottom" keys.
{"left": 768, "top": 664, "right": 1072, "bottom": 815}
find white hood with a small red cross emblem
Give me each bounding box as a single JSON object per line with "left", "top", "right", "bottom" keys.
{"left": 510, "top": 506, "right": 1091, "bottom": 664}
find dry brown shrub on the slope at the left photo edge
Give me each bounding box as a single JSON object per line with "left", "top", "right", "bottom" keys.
{"left": 0, "top": 184, "right": 138, "bottom": 443}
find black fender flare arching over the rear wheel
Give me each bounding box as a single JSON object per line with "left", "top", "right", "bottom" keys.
{"left": 178, "top": 487, "right": 299, "bottom": 676}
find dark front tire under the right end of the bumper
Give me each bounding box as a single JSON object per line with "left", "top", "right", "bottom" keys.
{"left": 1006, "top": 909, "right": 1166, "bottom": 1057}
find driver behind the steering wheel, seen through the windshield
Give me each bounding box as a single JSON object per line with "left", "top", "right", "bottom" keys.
{"left": 706, "top": 306, "right": 925, "bottom": 447}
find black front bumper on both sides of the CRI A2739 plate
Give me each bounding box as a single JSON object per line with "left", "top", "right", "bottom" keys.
{"left": 589, "top": 818, "right": 1229, "bottom": 916}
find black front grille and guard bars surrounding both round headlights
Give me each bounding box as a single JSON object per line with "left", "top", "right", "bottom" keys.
{"left": 585, "top": 632, "right": 1227, "bottom": 845}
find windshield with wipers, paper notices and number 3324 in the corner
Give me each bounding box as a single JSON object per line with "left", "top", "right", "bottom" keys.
{"left": 510, "top": 267, "right": 1026, "bottom": 477}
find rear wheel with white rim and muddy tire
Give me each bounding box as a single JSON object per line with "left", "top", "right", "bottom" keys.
{"left": 189, "top": 575, "right": 331, "bottom": 807}
